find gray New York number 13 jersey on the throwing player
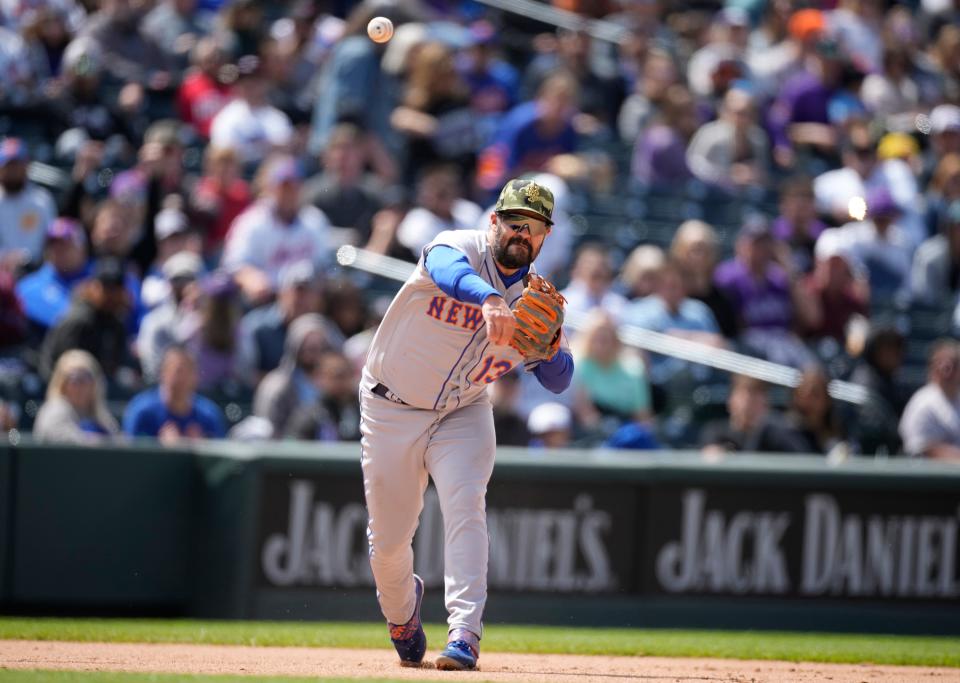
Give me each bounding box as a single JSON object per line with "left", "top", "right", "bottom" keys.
{"left": 364, "top": 230, "right": 536, "bottom": 411}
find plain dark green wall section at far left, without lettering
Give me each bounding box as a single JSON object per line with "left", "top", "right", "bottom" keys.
{"left": 9, "top": 446, "right": 198, "bottom": 612}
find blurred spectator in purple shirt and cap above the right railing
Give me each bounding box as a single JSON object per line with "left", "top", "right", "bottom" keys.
{"left": 714, "top": 216, "right": 813, "bottom": 367}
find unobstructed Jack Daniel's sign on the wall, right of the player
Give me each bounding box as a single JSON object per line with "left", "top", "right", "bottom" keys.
{"left": 652, "top": 488, "right": 960, "bottom": 600}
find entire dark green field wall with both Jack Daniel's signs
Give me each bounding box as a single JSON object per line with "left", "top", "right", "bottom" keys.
{"left": 0, "top": 442, "right": 960, "bottom": 633}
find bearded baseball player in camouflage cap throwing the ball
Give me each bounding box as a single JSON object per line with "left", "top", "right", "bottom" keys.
{"left": 360, "top": 180, "right": 573, "bottom": 670}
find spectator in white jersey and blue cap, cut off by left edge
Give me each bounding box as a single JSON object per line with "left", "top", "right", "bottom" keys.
{"left": 0, "top": 138, "right": 57, "bottom": 270}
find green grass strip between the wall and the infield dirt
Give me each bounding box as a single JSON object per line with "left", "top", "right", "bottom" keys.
{"left": 0, "top": 618, "right": 960, "bottom": 667}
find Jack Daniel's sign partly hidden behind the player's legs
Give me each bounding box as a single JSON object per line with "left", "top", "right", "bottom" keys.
{"left": 258, "top": 476, "right": 633, "bottom": 594}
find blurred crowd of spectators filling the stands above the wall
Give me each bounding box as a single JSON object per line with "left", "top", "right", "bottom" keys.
{"left": 0, "top": 0, "right": 960, "bottom": 460}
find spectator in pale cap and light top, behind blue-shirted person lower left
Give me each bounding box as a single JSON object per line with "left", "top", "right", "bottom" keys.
{"left": 136, "top": 251, "right": 203, "bottom": 382}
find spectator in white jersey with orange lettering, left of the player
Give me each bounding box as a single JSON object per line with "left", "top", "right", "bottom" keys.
{"left": 222, "top": 155, "right": 333, "bottom": 303}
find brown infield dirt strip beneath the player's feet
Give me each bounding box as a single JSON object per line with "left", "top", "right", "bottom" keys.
{"left": 0, "top": 640, "right": 960, "bottom": 683}
